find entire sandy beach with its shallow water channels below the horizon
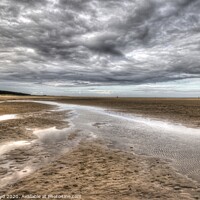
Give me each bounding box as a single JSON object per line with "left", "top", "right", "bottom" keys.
{"left": 0, "top": 97, "right": 200, "bottom": 199}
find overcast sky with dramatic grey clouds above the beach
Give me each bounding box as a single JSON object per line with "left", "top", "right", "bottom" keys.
{"left": 0, "top": 0, "right": 200, "bottom": 97}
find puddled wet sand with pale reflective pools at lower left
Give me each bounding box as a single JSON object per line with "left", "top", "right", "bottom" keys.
{"left": 0, "top": 127, "right": 78, "bottom": 189}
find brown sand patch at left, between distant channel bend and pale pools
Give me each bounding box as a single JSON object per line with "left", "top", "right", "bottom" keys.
{"left": 0, "top": 102, "right": 68, "bottom": 143}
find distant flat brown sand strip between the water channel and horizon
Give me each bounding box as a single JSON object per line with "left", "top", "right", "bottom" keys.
{"left": 0, "top": 95, "right": 200, "bottom": 127}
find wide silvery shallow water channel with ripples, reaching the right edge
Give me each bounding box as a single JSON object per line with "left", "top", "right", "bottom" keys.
{"left": 31, "top": 102, "right": 200, "bottom": 181}
